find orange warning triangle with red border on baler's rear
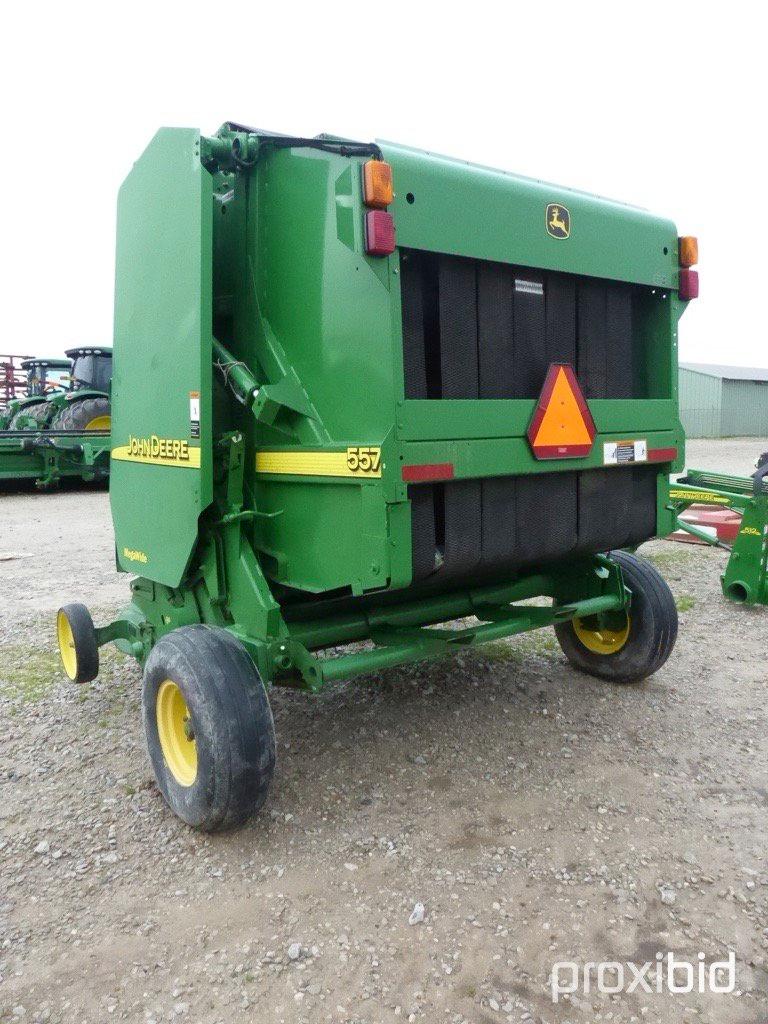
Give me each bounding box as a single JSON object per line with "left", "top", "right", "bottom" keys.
{"left": 528, "top": 362, "right": 597, "bottom": 459}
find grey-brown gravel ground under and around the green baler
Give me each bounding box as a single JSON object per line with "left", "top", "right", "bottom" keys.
{"left": 0, "top": 440, "right": 768, "bottom": 1024}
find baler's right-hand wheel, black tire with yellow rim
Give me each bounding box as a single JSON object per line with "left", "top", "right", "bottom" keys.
{"left": 555, "top": 551, "right": 677, "bottom": 683}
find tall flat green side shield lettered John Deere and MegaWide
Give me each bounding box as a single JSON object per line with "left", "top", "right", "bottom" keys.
{"left": 111, "top": 128, "right": 212, "bottom": 586}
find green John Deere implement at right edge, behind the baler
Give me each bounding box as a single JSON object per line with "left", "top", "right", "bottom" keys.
{"left": 670, "top": 459, "right": 768, "bottom": 604}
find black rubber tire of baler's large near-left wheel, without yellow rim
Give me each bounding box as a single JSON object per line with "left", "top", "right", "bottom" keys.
{"left": 142, "top": 625, "right": 275, "bottom": 831}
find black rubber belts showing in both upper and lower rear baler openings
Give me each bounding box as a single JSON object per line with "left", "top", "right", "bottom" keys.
{"left": 400, "top": 250, "right": 656, "bottom": 583}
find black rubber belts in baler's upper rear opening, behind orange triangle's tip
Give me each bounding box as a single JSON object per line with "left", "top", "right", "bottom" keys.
{"left": 400, "top": 250, "right": 640, "bottom": 398}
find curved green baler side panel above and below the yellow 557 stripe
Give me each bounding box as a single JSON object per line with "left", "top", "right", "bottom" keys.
{"left": 214, "top": 142, "right": 399, "bottom": 593}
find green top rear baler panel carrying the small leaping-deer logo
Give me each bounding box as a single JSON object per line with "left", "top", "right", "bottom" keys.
{"left": 381, "top": 142, "right": 678, "bottom": 288}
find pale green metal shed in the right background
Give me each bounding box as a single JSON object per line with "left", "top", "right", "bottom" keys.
{"left": 680, "top": 362, "right": 768, "bottom": 437}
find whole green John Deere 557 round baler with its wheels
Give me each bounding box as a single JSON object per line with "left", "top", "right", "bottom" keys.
{"left": 57, "top": 123, "right": 697, "bottom": 830}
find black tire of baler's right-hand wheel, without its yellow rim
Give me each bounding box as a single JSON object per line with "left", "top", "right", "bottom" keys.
{"left": 555, "top": 551, "right": 678, "bottom": 683}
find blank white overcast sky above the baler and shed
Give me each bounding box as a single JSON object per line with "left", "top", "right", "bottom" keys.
{"left": 0, "top": 0, "right": 768, "bottom": 366}
